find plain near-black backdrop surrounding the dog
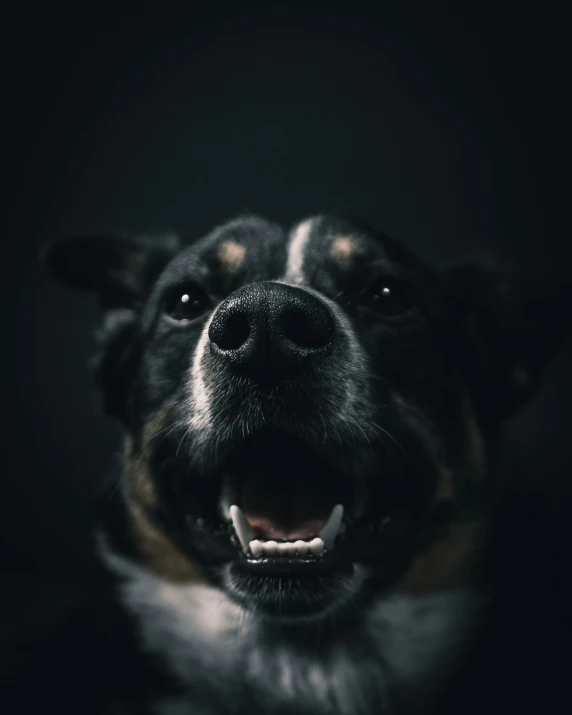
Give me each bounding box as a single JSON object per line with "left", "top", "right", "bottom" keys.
{"left": 0, "top": 2, "right": 572, "bottom": 712}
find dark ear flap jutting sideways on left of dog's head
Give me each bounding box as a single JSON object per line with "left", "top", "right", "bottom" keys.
{"left": 41, "top": 234, "right": 179, "bottom": 310}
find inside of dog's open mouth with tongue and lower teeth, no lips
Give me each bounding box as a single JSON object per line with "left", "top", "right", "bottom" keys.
{"left": 220, "top": 432, "right": 359, "bottom": 571}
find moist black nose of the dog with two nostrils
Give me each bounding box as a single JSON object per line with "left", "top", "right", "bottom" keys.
{"left": 209, "top": 282, "right": 334, "bottom": 384}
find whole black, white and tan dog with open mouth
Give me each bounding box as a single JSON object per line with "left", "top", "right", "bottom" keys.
{"left": 44, "top": 215, "right": 572, "bottom": 715}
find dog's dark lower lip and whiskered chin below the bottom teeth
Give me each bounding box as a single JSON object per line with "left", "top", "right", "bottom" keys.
{"left": 183, "top": 519, "right": 415, "bottom": 622}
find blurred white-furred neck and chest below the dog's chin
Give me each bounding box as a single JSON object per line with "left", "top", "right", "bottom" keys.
{"left": 102, "top": 545, "right": 483, "bottom": 715}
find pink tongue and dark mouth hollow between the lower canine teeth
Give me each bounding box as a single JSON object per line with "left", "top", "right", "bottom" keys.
{"left": 240, "top": 477, "right": 335, "bottom": 541}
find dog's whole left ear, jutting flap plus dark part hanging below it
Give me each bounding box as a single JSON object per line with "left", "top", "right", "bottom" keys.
{"left": 41, "top": 234, "right": 180, "bottom": 422}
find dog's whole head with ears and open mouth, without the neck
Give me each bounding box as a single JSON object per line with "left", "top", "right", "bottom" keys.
{"left": 45, "top": 216, "right": 561, "bottom": 618}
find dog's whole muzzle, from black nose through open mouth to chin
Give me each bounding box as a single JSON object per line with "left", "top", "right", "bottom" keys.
{"left": 176, "top": 281, "right": 432, "bottom": 615}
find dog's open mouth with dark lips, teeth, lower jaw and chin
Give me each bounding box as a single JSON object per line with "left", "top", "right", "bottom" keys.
{"left": 171, "top": 429, "right": 432, "bottom": 613}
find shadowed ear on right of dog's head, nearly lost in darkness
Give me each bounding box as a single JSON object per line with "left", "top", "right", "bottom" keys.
{"left": 445, "top": 266, "right": 572, "bottom": 429}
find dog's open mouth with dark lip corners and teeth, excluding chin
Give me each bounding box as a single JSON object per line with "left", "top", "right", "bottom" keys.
{"left": 180, "top": 429, "right": 420, "bottom": 574}
